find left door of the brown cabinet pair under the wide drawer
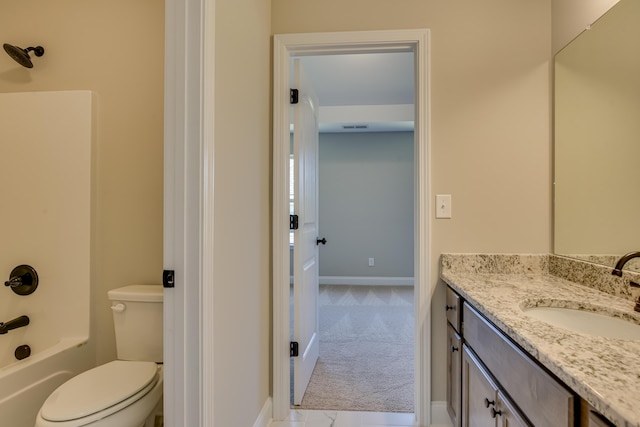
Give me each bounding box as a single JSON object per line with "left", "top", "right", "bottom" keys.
{"left": 462, "top": 345, "right": 498, "bottom": 427}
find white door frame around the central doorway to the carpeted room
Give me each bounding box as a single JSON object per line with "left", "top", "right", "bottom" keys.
{"left": 272, "top": 29, "right": 433, "bottom": 425}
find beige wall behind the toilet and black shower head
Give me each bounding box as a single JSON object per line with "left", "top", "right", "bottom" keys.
{"left": 0, "top": 0, "right": 164, "bottom": 363}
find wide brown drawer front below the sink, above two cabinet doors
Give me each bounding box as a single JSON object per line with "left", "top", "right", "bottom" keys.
{"left": 463, "top": 303, "right": 574, "bottom": 427}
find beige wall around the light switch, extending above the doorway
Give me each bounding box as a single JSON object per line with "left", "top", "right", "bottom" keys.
{"left": 272, "top": 0, "right": 551, "bottom": 401}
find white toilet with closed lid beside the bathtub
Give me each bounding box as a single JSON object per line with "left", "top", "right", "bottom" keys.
{"left": 35, "top": 285, "right": 163, "bottom": 427}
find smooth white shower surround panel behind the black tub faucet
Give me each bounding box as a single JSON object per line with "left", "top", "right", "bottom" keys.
{"left": 0, "top": 91, "right": 94, "bottom": 360}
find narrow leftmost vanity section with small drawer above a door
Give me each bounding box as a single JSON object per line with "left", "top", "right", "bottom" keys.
{"left": 445, "top": 287, "right": 462, "bottom": 427}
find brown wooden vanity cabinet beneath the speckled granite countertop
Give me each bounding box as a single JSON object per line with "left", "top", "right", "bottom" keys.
{"left": 447, "top": 288, "right": 576, "bottom": 427}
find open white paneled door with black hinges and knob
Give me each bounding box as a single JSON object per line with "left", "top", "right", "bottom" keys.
{"left": 292, "top": 59, "right": 320, "bottom": 405}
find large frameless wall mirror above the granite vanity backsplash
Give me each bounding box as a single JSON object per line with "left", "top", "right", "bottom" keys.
{"left": 554, "top": 0, "right": 640, "bottom": 271}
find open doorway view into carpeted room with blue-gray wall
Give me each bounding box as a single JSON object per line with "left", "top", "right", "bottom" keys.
{"left": 290, "top": 52, "right": 415, "bottom": 413}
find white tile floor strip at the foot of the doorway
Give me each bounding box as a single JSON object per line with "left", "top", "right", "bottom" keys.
{"left": 269, "top": 410, "right": 446, "bottom": 427}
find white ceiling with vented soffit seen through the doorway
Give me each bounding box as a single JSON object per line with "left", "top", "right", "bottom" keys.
{"left": 300, "top": 52, "right": 414, "bottom": 132}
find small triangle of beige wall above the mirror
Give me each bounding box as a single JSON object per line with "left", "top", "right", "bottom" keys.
{"left": 551, "top": 0, "right": 619, "bottom": 53}
